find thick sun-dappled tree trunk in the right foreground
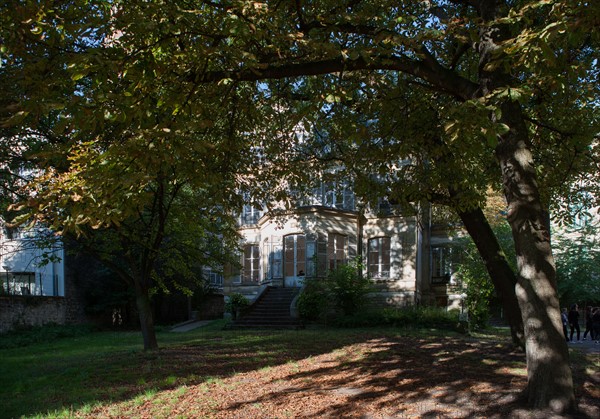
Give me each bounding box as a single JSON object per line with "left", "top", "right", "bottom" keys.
{"left": 496, "top": 103, "right": 575, "bottom": 413}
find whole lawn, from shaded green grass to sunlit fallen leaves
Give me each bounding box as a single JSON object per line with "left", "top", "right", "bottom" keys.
{"left": 0, "top": 321, "right": 600, "bottom": 418}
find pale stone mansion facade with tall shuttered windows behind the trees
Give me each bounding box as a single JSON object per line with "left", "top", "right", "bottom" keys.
{"left": 223, "top": 184, "right": 454, "bottom": 307}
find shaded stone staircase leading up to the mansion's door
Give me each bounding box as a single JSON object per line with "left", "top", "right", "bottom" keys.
{"left": 229, "top": 287, "right": 303, "bottom": 329}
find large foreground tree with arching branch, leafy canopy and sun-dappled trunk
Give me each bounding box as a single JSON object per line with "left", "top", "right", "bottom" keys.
{"left": 0, "top": 0, "right": 600, "bottom": 411}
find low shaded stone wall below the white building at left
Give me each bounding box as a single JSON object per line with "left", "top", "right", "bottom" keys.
{"left": 0, "top": 296, "right": 83, "bottom": 333}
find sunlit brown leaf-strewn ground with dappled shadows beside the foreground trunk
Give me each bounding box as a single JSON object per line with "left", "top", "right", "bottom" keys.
{"left": 89, "top": 337, "right": 600, "bottom": 419}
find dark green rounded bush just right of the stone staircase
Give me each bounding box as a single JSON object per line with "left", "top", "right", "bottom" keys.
{"left": 298, "top": 260, "right": 372, "bottom": 320}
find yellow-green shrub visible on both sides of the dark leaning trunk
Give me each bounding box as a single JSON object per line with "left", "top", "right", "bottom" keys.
{"left": 456, "top": 217, "right": 516, "bottom": 330}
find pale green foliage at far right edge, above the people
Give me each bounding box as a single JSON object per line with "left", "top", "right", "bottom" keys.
{"left": 554, "top": 224, "right": 600, "bottom": 307}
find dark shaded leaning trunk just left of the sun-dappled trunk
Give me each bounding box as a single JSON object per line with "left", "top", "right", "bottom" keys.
{"left": 458, "top": 208, "right": 525, "bottom": 349}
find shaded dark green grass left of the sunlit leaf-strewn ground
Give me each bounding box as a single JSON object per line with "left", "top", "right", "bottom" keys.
{"left": 0, "top": 324, "right": 394, "bottom": 417}
